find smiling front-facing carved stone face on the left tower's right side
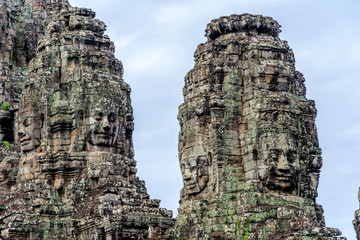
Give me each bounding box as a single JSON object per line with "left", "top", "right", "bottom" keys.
{"left": 88, "top": 111, "right": 119, "bottom": 147}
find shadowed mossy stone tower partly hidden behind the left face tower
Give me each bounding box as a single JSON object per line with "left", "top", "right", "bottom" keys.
{"left": 0, "top": 0, "right": 70, "bottom": 195}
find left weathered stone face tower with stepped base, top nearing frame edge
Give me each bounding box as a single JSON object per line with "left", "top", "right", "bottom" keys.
{"left": 0, "top": 1, "right": 174, "bottom": 240}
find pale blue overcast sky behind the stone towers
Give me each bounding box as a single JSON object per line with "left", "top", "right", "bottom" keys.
{"left": 70, "top": 0, "right": 360, "bottom": 240}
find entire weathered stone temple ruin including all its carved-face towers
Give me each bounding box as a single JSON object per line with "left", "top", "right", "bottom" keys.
{"left": 0, "top": 0, "right": 348, "bottom": 240}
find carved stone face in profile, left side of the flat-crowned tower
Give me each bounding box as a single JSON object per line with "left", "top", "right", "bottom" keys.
{"left": 181, "top": 156, "right": 209, "bottom": 195}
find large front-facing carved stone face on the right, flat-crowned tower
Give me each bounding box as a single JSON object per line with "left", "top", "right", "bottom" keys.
{"left": 259, "top": 133, "right": 300, "bottom": 192}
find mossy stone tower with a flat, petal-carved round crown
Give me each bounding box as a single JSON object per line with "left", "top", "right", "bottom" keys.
{"left": 175, "top": 14, "right": 345, "bottom": 239}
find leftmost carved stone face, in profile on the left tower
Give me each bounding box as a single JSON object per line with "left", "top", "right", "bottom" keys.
{"left": 19, "top": 117, "right": 41, "bottom": 152}
